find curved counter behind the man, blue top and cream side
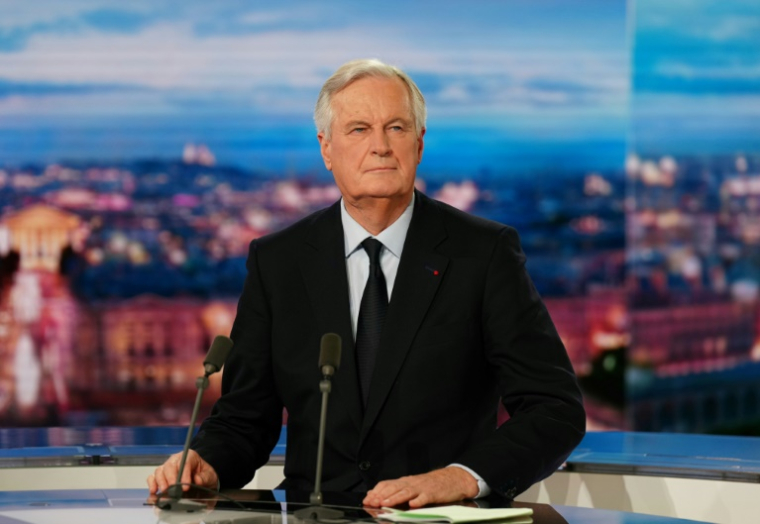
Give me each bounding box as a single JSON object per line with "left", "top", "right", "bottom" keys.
{"left": 0, "top": 427, "right": 760, "bottom": 524}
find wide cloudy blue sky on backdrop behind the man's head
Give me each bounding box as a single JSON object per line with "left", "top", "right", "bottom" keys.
{"left": 0, "top": 0, "right": 648, "bottom": 175}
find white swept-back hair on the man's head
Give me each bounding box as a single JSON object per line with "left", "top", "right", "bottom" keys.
{"left": 314, "top": 58, "right": 427, "bottom": 139}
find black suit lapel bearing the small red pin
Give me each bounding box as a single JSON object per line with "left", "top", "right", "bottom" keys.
{"left": 357, "top": 193, "right": 449, "bottom": 445}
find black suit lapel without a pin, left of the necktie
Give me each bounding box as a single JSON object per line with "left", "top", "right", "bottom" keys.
{"left": 300, "top": 202, "right": 362, "bottom": 430}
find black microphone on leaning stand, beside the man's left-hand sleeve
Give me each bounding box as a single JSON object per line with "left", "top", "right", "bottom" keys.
{"left": 156, "top": 335, "right": 232, "bottom": 512}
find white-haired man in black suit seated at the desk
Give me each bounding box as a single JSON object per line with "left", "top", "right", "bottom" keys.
{"left": 148, "top": 60, "right": 585, "bottom": 507}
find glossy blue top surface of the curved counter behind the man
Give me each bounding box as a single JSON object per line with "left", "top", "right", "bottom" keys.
{"left": 0, "top": 427, "right": 760, "bottom": 483}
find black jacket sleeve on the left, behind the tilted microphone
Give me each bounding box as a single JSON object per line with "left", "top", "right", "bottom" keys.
{"left": 191, "top": 241, "right": 283, "bottom": 488}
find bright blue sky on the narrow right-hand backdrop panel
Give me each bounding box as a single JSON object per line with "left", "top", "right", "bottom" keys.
{"left": 631, "top": 0, "right": 760, "bottom": 156}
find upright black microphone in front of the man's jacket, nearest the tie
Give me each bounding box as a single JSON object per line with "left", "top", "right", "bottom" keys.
{"left": 294, "top": 333, "right": 343, "bottom": 520}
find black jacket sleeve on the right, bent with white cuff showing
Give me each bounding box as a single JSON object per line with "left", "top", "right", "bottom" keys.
{"left": 460, "top": 227, "right": 585, "bottom": 497}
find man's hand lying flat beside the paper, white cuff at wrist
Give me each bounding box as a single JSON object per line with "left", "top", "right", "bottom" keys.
{"left": 363, "top": 466, "right": 478, "bottom": 508}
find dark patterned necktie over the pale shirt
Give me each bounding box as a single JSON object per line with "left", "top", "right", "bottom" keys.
{"left": 356, "top": 238, "right": 388, "bottom": 406}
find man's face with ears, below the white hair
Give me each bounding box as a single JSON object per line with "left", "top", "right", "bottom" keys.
{"left": 317, "top": 77, "right": 425, "bottom": 203}
